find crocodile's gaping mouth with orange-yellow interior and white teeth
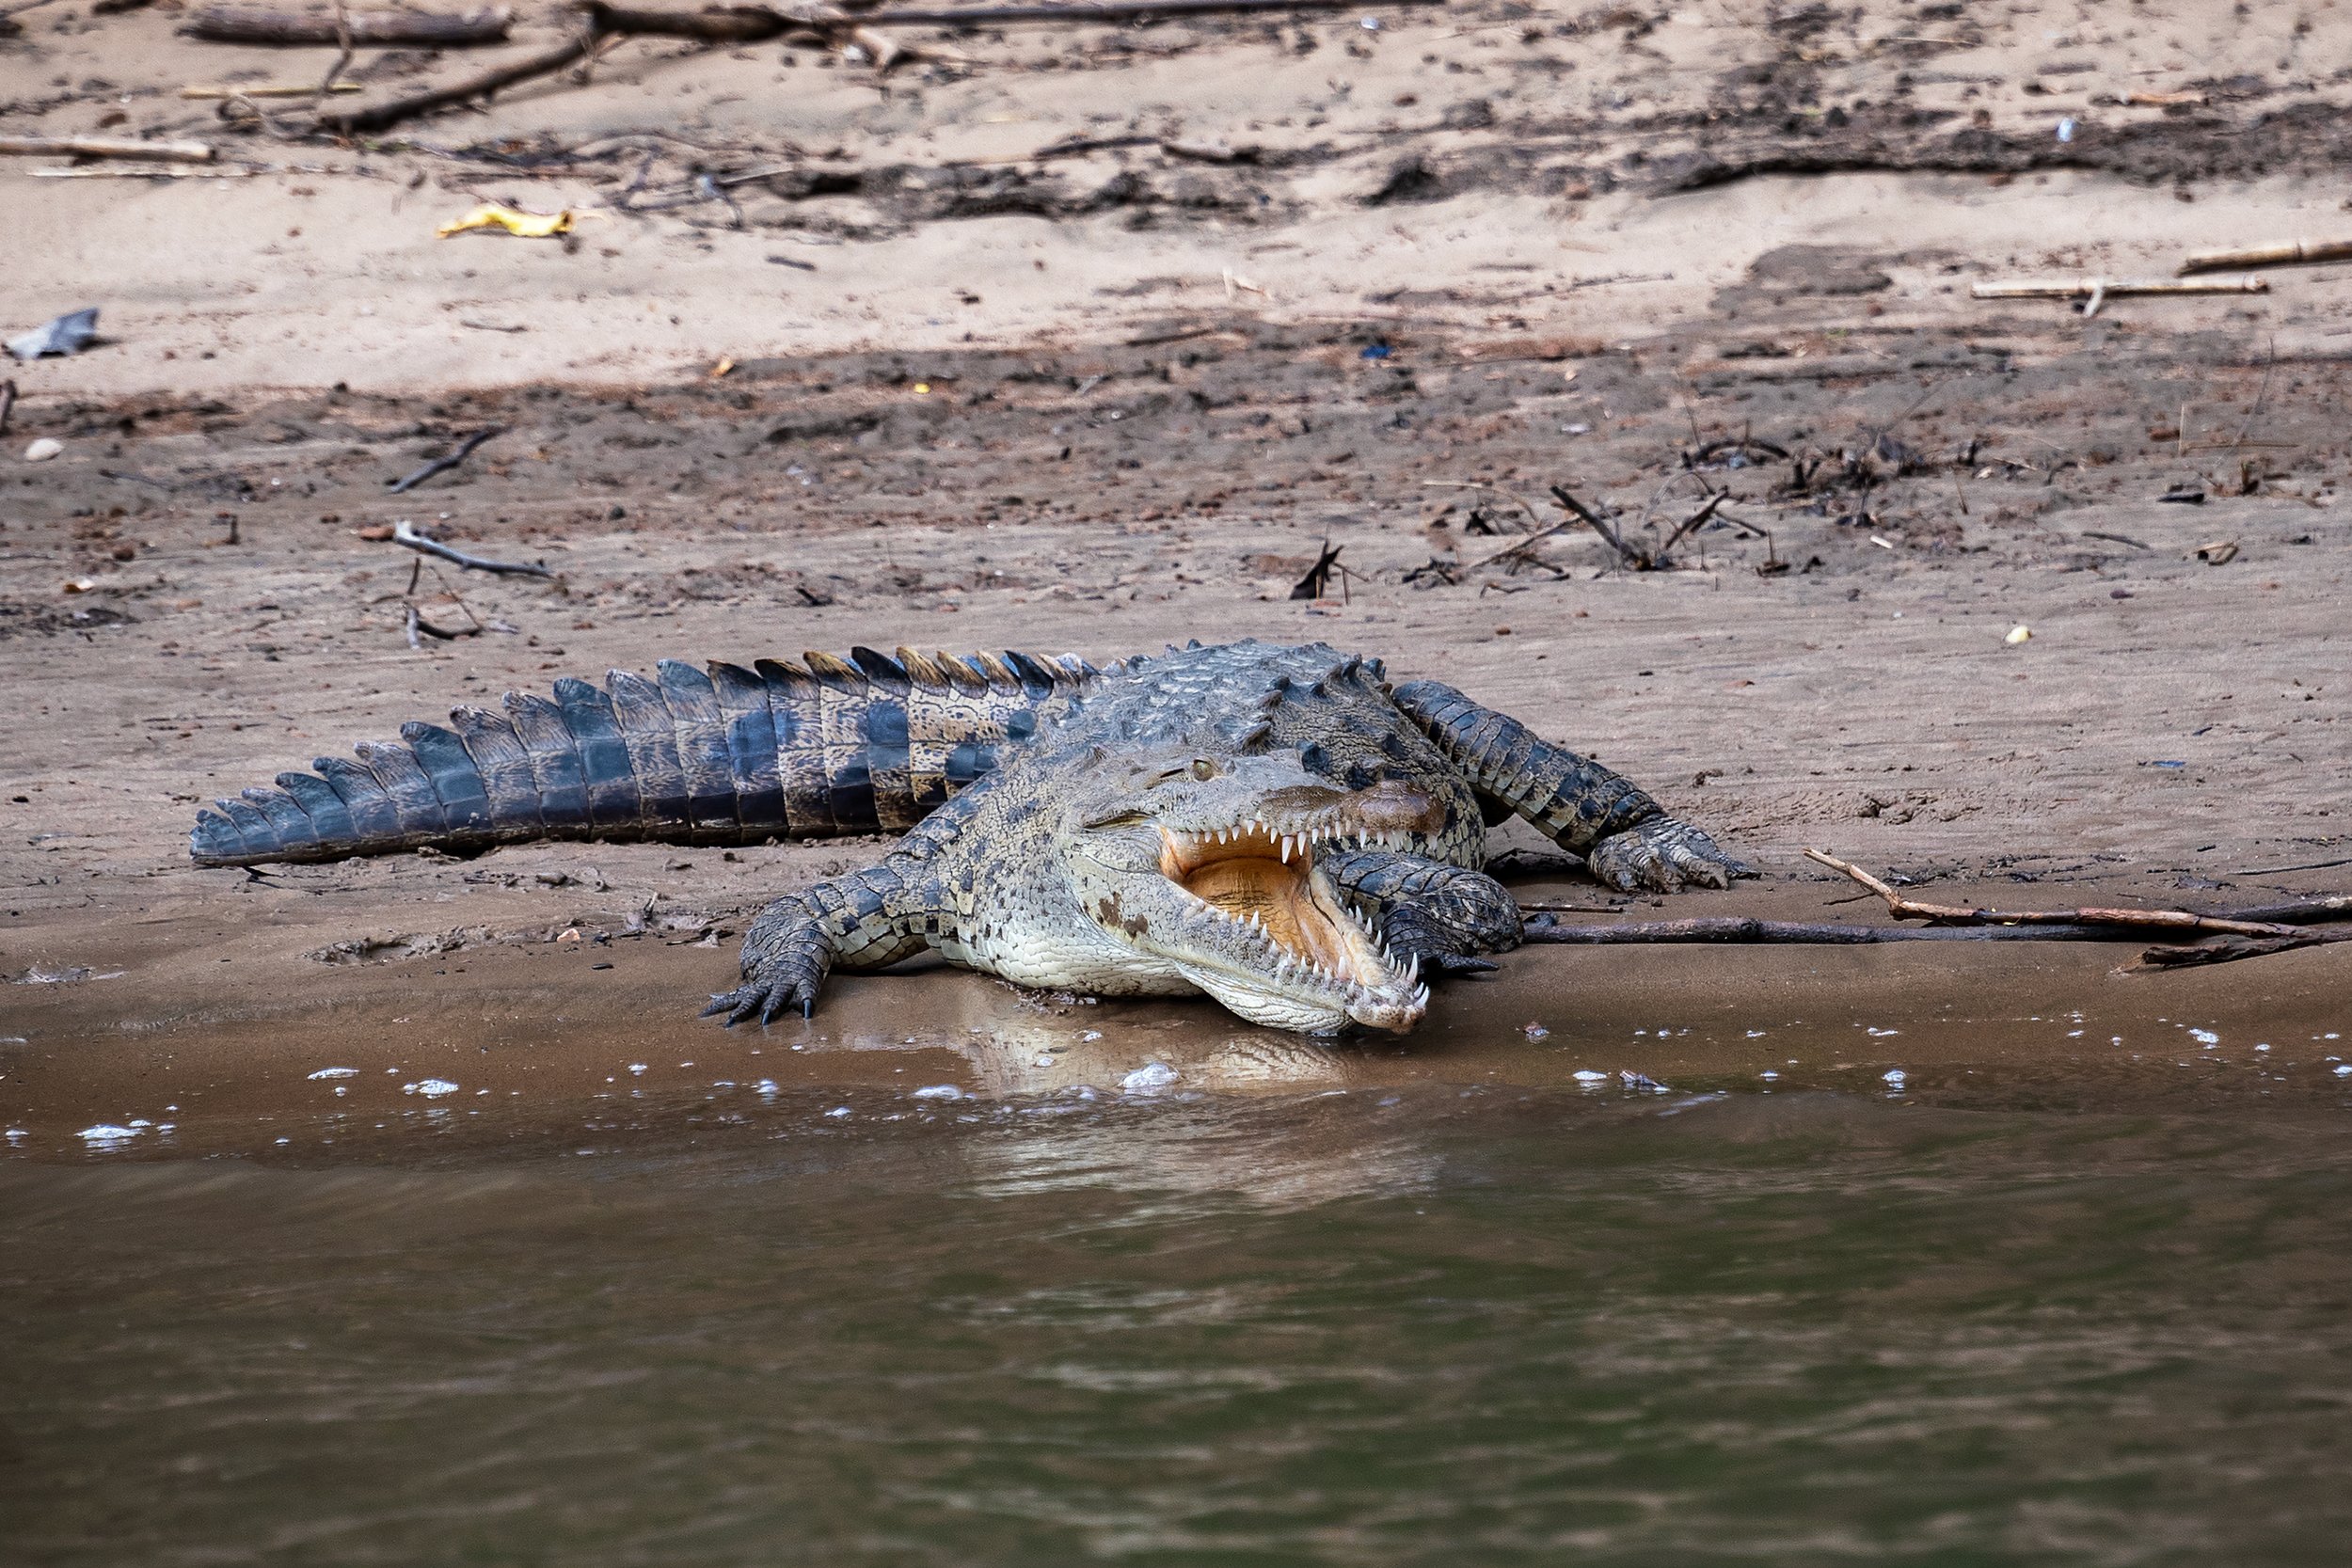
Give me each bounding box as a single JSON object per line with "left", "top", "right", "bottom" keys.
{"left": 1160, "top": 818, "right": 1428, "bottom": 1030}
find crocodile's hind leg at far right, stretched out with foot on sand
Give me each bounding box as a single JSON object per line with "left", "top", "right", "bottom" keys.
{"left": 1395, "top": 682, "right": 1757, "bottom": 891}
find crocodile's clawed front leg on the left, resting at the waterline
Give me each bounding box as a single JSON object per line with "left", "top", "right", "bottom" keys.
{"left": 704, "top": 853, "right": 936, "bottom": 1027}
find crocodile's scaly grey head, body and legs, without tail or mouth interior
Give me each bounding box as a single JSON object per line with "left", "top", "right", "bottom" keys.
{"left": 708, "top": 644, "right": 1748, "bottom": 1032}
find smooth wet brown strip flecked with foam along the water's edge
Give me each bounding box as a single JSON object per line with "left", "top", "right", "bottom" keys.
{"left": 8, "top": 869, "right": 2352, "bottom": 1164}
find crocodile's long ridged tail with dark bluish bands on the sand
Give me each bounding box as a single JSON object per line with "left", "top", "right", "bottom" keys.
{"left": 188, "top": 649, "right": 1099, "bottom": 865}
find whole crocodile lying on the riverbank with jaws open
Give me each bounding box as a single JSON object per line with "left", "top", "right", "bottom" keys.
{"left": 191, "top": 641, "right": 1755, "bottom": 1035}
